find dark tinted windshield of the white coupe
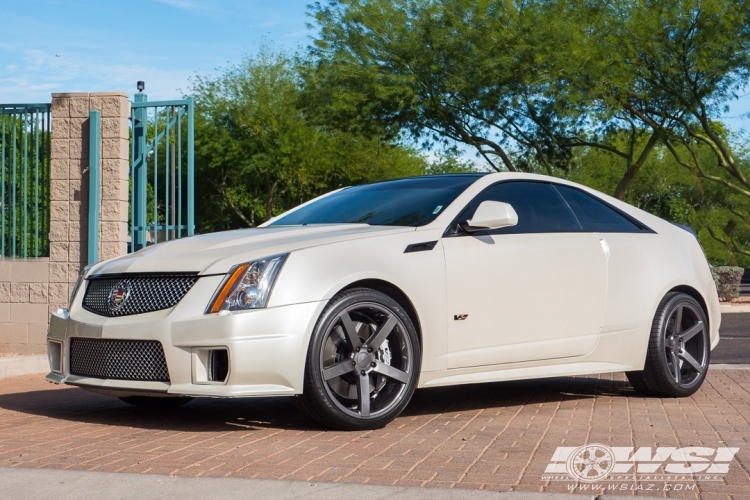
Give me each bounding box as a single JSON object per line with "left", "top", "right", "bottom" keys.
{"left": 270, "top": 174, "right": 481, "bottom": 227}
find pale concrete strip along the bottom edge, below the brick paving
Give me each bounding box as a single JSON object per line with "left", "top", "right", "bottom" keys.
{"left": 0, "top": 467, "right": 612, "bottom": 500}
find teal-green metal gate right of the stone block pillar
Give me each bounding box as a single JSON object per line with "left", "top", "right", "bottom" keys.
{"left": 130, "top": 93, "right": 195, "bottom": 251}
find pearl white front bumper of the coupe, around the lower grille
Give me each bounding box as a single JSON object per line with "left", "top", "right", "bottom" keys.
{"left": 47, "top": 276, "right": 326, "bottom": 397}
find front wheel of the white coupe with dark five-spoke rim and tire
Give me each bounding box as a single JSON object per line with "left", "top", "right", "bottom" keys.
{"left": 297, "top": 288, "right": 422, "bottom": 430}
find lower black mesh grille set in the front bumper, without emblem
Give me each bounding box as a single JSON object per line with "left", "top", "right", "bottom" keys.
{"left": 70, "top": 337, "right": 169, "bottom": 382}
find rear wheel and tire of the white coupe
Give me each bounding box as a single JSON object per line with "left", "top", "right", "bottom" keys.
{"left": 626, "top": 292, "right": 711, "bottom": 398}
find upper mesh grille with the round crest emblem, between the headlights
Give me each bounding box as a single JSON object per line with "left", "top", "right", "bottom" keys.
{"left": 83, "top": 274, "right": 198, "bottom": 317}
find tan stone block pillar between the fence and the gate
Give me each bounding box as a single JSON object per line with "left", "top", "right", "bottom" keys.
{"left": 49, "top": 92, "right": 130, "bottom": 304}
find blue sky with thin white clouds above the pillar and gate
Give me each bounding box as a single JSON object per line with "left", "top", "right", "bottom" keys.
{"left": 0, "top": 0, "right": 750, "bottom": 130}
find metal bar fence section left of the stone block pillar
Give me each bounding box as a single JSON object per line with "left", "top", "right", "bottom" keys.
{"left": 0, "top": 104, "right": 50, "bottom": 258}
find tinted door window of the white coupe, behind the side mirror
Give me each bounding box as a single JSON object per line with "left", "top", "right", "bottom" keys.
{"left": 462, "top": 181, "right": 581, "bottom": 234}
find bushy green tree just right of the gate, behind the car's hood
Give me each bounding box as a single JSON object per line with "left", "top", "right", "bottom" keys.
{"left": 194, "top": 48, "right": 427, "bottom": 231}
